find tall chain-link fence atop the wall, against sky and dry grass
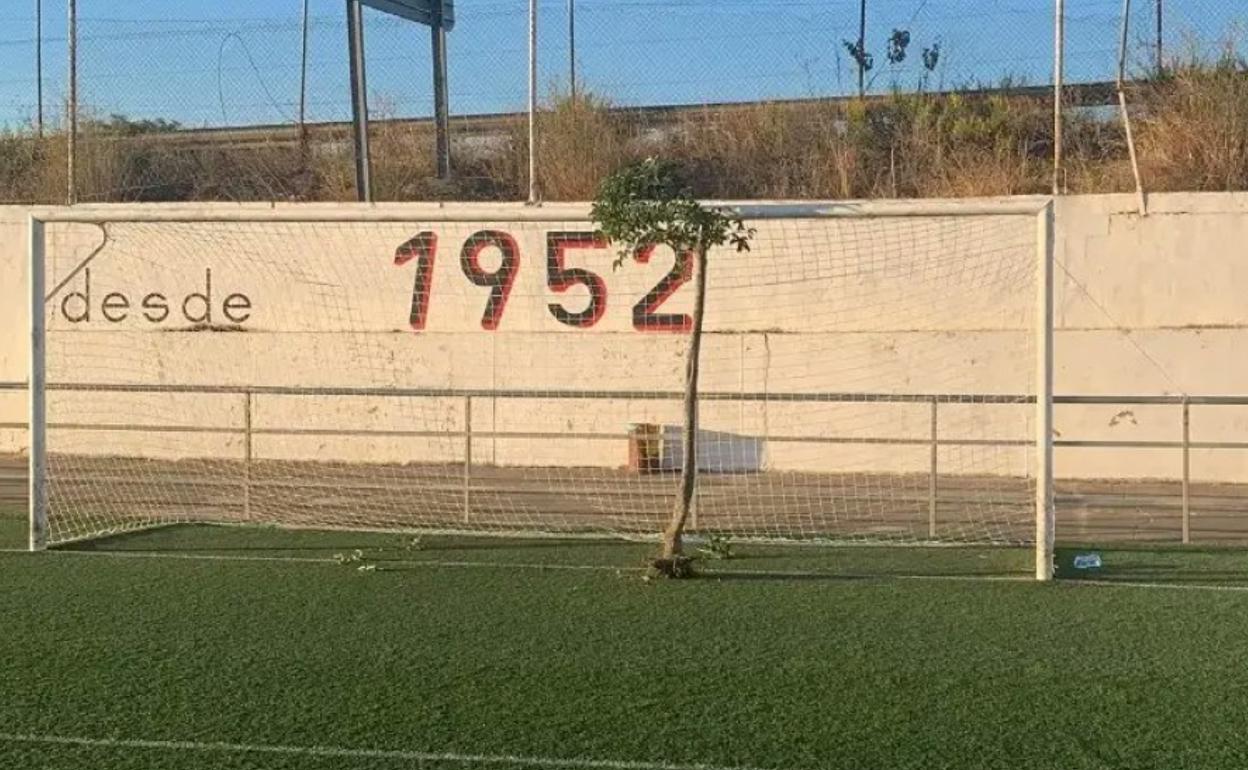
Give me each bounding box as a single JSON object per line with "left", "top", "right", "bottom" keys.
{"left": 0, "top": 0, "right": 1248, "bottom": 202}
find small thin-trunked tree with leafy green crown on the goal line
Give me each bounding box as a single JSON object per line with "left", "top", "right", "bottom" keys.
{"left": 593, "top": 158, "right": 754, "bottom": 578}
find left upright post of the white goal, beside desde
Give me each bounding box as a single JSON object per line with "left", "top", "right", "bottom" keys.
{"left": 27, "top": 217, "right": 47, "bottom": 550}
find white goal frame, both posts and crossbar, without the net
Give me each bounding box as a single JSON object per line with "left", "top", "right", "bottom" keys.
{"left": 27, "top": 197, "right": 1056, "bottom": 580}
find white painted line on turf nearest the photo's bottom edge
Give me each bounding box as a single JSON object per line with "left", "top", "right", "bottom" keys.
{"left": 0, "top": 733, "right": 760, "bottom": 770}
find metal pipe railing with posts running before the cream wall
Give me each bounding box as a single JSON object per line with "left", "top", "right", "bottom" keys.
{"left": 0, "top": 382, "right": 1248, "bottom": 544}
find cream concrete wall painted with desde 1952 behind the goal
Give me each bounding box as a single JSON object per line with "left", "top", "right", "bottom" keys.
{"left": 0, "top": 195, "right": 1248, "bottom": 480}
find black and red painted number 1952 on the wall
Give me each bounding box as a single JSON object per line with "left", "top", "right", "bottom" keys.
{"left": 394, "top": 230, "right": 694, "bottom": 332}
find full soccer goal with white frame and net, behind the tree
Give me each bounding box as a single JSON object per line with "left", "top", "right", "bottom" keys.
{"left": 30, "top": 198, "right": 1053, "bottom": 579}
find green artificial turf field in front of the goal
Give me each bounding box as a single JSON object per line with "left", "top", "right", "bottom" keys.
{"left": 0, "top": 504, "right": 1248, "bottom": 770}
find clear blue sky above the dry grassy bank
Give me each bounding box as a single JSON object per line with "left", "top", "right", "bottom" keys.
{"left": 0, "top": 0, "right": 1248, "bottom": 127}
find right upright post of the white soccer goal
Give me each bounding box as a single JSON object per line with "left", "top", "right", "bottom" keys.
{"left": 1036, "top": 202, "right": 1056, "bottom": 580}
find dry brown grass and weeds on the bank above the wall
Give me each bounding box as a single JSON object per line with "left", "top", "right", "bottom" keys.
{"left": 0, "top": 59, "right": 1248, "bottom": 202}
